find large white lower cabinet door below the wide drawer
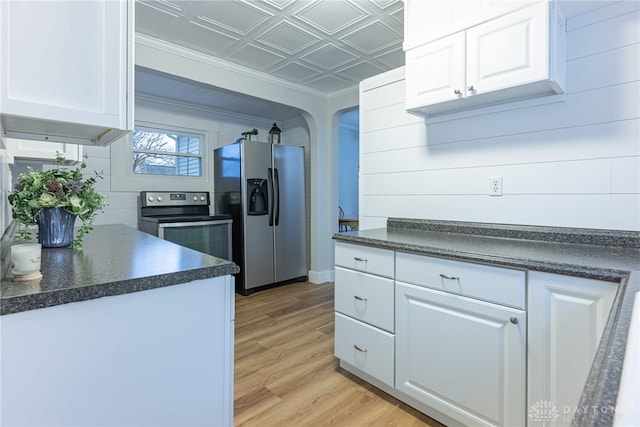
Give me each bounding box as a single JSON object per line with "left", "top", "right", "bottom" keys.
{"left": 396, "top": 282, "right": 527, "bottom": 426}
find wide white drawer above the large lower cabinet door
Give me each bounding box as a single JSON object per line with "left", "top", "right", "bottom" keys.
{"left": 396, "top": 252, "right": 525, "bottom": 309}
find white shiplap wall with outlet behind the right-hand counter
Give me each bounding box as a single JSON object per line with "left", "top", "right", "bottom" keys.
{"left": 360, "top": 1, "right": 640, "bottom": 230}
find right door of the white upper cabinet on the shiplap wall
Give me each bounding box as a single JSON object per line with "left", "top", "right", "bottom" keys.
{"left": 466, "top": 1, "right": 549, "bottom": 96}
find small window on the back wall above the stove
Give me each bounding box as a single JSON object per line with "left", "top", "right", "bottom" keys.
{"left": 132, "top": 129, "right": 203, "bottom": 176}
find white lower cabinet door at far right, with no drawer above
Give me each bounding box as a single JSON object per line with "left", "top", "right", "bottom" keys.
{"left": 528, "top": 272, "right": 618, "bottom": 426}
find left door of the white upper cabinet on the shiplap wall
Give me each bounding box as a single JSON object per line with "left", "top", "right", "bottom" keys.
{"left": 405, "top": 33, "right": 465, "bottom": 109}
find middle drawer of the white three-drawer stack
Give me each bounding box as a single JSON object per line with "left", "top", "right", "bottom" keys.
{"left": 335, "top": 267, "right": 394, "bottom": 332}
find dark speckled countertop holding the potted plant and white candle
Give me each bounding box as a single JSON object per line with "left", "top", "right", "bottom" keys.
{"left": 0, "top": 225, "right": 239, "bottom": 315}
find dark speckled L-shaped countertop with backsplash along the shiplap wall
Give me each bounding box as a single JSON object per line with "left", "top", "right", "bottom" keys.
{"left": 334, "top": 218, "right": 640, "bottom": 427}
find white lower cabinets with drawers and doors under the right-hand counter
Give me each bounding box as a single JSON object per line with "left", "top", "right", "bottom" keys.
{"left": 335, "top": 242, "right": 618, "bottom": 427}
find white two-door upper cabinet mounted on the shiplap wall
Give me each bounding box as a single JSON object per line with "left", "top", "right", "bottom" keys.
{"left": 405, "top": 1, "right": 565, "bottom": 116}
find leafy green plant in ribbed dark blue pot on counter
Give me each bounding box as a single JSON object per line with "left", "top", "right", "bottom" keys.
{"left": 8, "top": 153, "right": 107, "bottom": 249}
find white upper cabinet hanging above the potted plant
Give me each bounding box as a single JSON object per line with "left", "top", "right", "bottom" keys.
{"left": 0, "top": 0, "right": 134, "bottom": 145}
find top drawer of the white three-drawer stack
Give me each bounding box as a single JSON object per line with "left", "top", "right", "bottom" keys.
{"left": 335, "top": 242, "right": 394, "bottom": 278}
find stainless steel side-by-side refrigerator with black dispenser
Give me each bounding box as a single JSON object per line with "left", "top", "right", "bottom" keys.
{"left": 214, "top": 140, "right": 308, "bottom": 295}
